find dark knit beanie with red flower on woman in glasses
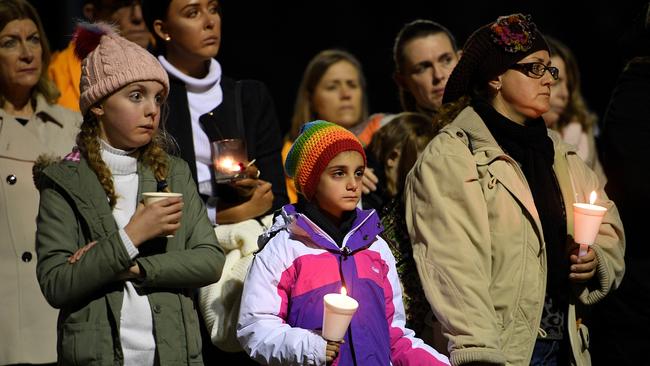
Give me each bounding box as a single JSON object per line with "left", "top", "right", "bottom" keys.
{"left": 442, "top": 14, "right": 550, "bottom": 103}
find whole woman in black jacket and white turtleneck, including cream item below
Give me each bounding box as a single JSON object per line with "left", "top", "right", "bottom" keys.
{"left": 141, "top": 0, "right": 288, "bottom": 364}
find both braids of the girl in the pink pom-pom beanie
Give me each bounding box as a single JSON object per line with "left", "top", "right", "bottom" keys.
{"left": 77, "top": 112, "right": 169, "bottom": 208}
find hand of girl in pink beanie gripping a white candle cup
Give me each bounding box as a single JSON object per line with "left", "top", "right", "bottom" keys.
{"left": 124, "top": 197, "right": 183, "bottom": 247}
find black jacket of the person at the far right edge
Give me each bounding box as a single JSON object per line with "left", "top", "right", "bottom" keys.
{"left": 590, "top": 60, "right": 650, "bottom": 366}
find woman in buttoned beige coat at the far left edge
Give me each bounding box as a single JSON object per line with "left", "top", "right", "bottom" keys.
{"left": 0, "top": 0, "right": 81, "bottom": 365}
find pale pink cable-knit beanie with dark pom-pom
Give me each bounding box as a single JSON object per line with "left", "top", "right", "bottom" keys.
{"left": 73, "top": 23, "right": 169, "bottom": 115}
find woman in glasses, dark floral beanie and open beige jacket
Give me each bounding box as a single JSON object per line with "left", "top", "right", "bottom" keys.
{"left": 405, "top": 14, "right": 624, "bottom": 365}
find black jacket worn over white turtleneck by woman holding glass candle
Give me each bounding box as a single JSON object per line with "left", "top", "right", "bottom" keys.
{"left": 166, "top": 75, "right": 289, "bottom": 211}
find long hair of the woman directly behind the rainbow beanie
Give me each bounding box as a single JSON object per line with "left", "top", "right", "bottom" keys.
{"left": 287, "top": 49, "right": 368, "bottom": 141}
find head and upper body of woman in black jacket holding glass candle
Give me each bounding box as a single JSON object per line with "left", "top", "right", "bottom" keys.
{"left": 142, "top": 0, "right": 287, "bottom": 224}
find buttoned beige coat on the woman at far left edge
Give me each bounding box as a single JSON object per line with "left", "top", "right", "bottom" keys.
{"left": 0, "top": 97, "right": 81, "bottom": 365}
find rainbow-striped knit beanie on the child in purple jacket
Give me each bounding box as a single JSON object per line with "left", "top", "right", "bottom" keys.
{"left": 284, "top": 121, "right": 366, "bottom": 201}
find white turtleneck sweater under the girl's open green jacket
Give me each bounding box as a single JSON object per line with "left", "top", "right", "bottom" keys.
{"left": 100, "top": 140, "right": 156, "bottom": 366}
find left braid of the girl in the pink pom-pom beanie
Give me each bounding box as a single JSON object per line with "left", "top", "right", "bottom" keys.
{"left": 77, "top": 113, "right": 117, "bottom": 208}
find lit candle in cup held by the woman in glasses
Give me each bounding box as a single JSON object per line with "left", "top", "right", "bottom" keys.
{"left": 573, "top": 191, "right": 607, "bottom": 257}
